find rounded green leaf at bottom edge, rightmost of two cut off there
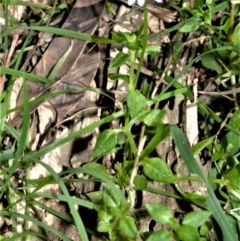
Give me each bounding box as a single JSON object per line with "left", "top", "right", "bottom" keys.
{"left": 176, "top": 225, "right": 200, "bottom": 241}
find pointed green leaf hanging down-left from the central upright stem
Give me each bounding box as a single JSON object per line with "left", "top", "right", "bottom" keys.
{"left": 93, "top": 130, "right": 117, "bottom": 158}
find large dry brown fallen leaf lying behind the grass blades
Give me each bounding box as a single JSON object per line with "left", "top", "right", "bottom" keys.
{"left": 11, "top": 0, "right": 106, "bottom": 127}
